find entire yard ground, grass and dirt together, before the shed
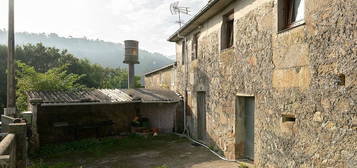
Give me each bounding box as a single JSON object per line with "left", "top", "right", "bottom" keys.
{"left": 31, "top": 135, "right": 245, "bottom": 168}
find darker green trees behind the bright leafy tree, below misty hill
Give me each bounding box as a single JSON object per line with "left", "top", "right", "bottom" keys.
{"left": 0, "top": 43, "right": 141, "bottom": 109}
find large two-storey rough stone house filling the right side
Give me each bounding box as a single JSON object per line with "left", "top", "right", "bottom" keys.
{"left": 165, "top": 0, "right": 357, "bottom": 167}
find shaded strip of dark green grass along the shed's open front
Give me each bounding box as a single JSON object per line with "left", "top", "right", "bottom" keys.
{"left": 30, "top": 134, "right": 185, "bottom": 168}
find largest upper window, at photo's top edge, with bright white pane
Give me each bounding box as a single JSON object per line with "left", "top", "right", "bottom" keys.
{"left": 278, "top": 0, "right": 305, "bottom": 31}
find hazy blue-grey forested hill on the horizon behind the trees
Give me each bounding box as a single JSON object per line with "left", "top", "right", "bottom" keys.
{"left": 0, "top": 30, "right": 174, "bottom": 75}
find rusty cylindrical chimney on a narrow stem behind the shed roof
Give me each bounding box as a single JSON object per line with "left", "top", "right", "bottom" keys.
{"left": 124, "top": 40, "right": 139, "bottom": 89}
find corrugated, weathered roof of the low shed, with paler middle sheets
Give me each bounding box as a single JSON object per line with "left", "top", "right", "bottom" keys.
{"left": 27, "top": 88, "right": 180, "bottom": 105}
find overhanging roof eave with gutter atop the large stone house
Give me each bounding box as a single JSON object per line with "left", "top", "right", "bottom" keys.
{"left": 168, "top": 0, "right": 236, "bottom": 42}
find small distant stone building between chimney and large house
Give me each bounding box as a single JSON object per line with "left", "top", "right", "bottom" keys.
{"left": 144, "top": 62, "right": 176, "bottom": 91}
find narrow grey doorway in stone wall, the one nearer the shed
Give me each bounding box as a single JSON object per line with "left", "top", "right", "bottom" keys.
{"left": 197, "top": 92, "right": 206, "bottom": 141}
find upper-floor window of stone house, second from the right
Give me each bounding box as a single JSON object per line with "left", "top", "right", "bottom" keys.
{"left": 221, "top": 10, "right": 234, "bottom": 50}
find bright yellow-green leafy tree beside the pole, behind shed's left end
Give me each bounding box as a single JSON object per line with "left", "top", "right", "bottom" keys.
{"left": 16, "top": 61, "right": 86, "bottom": 111}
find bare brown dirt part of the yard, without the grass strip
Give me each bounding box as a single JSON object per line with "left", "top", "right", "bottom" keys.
{"left": 83, "top": 141, "right": 239, "bottom": 168}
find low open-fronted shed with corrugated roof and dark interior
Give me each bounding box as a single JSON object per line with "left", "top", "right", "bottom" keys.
{"left": 28, "top": 89, "right": 181, "bottom": 148}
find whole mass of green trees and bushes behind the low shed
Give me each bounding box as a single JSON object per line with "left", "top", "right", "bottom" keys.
{"left": 0, "top": 44, "right": 140, "bottom": 110}
